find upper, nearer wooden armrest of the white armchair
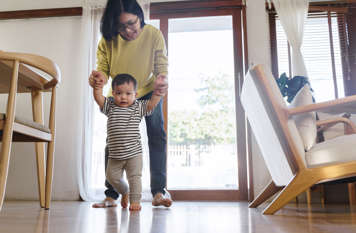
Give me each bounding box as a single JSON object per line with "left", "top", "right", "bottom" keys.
{"left": 287, "top": 95, "right": 356, "bottom": 116}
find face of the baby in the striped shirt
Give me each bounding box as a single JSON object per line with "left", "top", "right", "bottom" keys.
{"left": 112, "top": 82, "right": 136, "bottom": 107}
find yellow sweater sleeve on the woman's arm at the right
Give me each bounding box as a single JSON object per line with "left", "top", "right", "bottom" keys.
{"left": 153, "top": 31, "right": 168, "bottom": 76}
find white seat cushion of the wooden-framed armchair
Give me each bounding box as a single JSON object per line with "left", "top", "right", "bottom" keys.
{"left": 305, "top": 134, "right": 356, "bottom": 167}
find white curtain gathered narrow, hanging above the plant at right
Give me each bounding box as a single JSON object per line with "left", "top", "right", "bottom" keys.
{"left": 272, "top": 0, "right": 309, "bottom": 77}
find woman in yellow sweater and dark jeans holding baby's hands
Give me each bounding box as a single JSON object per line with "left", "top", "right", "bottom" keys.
{"left": 89, "top": 0, "right": 172, "bottom": 208}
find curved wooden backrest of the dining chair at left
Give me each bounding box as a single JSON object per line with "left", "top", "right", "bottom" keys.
{"left": 0, "top": 50, "right": 61, "bottom": 93}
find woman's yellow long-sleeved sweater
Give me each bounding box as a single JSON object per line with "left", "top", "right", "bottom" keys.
{"left": 97, "top": 24, "right": 168, "bottom": 98}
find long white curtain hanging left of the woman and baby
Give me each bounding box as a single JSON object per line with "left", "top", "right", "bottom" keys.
{"left": 78, "top": 0, "right": 105, "bottom": 201}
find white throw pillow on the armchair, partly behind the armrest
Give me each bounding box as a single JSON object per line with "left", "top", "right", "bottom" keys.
{"left": 289, "top": 84, "right": 317, "bottom": 151}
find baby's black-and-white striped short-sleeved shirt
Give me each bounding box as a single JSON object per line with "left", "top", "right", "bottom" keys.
{"left": 101, "top": 97, "right": 152, "bottom": 160}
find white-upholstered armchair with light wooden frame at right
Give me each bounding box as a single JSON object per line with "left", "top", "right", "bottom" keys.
{"left": 241, "top": 65, "right": 356, "bottom": 214}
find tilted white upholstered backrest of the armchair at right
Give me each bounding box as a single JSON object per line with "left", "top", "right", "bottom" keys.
{"left": 241, "top": 65, "right": 305, "bottom": 186}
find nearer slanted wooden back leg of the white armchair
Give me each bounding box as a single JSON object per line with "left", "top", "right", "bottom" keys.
{"left": 263, "top": 171, "right": 316, "bottom": 214}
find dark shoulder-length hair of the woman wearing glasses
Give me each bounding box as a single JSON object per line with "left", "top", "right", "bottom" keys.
{"left": 100, "top": 0, "right": 145, "bottom": 41}
